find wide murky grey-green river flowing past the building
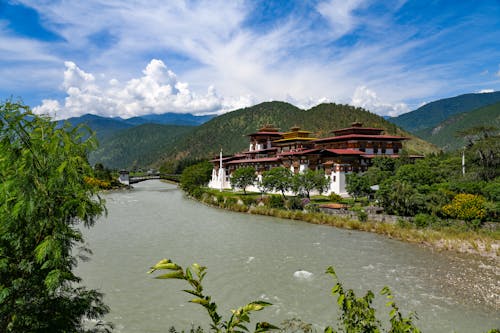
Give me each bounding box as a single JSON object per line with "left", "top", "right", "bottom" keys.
{"left": 77, "top": 180, "right": 500, "bottom": 333}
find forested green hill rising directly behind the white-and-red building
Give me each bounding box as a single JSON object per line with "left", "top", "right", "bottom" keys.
{"left": 157, "top": 102, "right": 437, "bottom": 165}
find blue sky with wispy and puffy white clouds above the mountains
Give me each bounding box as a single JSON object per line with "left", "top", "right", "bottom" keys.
{"left": 0, "top": 0, "right": 500, "bottom": 119}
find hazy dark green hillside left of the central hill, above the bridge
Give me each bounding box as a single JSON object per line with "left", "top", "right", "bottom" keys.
{"left": 89, "top": 124, "right": 193, "bottom": 169}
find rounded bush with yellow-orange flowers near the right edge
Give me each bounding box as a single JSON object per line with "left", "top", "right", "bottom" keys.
{"left": 442, "top": 193, "right": 486, "bottom": 221}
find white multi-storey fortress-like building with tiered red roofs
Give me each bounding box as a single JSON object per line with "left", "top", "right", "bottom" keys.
{"left": 209, "top": 123, "right": 408, "bottom": 196}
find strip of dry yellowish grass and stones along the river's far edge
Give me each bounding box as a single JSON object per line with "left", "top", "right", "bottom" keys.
{"left": 186, "top": 190, "right": 500, "bottom": 260}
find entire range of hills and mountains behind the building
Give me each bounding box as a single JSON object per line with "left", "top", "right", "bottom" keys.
{"left": 64, "top": 92, "right": 500, "bottom": 169}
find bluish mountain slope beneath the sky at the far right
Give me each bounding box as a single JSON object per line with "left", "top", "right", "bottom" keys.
{"left": 390, "top": 91, "right": 500, "bottom": 132}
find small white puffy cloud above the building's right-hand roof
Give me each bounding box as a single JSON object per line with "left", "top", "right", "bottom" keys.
{"left": 351, "top": 86, "right": 410, "bottom": 117}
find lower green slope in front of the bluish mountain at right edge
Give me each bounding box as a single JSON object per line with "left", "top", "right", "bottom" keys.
{"left": 415, "top": 102, "right": 500, "bottom": 151}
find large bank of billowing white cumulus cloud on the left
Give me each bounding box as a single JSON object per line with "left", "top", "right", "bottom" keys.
{"left": 34, "top": 59, "right": 249, "bottom": 119}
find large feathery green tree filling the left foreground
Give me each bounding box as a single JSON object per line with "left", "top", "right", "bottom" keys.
{"left": 0, "top": 101, "right": 109, "bottom": 332}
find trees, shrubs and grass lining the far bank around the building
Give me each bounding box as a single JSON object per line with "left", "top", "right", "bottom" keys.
{"left": 180, "top": 133, "right": 500, "bottom": 257}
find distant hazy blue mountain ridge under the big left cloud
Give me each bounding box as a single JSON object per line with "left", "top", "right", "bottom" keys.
{"left": 123, "top": 112, "right": 215, "bottom": 126}
